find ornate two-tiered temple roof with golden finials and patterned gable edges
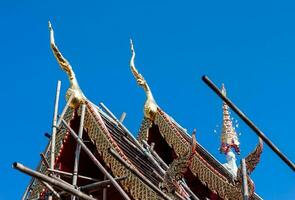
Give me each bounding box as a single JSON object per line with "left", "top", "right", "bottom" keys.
{"left": 20, "top": 22, "right": 262, "bottom": 200}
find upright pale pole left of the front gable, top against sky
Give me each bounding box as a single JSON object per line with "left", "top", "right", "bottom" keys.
{"left": 48, "top": 80, "right": 61, "bottom": 200}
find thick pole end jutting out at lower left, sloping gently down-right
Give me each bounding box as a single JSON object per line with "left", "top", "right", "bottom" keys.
{"left": 13, "top": 162, "right": 96, "bottom": 200}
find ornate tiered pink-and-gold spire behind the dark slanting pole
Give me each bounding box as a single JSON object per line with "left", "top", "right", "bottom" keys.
{"left": 219, "top": 84, "right": 240, "bottom": 154}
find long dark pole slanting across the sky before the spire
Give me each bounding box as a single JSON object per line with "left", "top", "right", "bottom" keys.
{"left": 202, "top": 75, "right": 295, "bottom": 172}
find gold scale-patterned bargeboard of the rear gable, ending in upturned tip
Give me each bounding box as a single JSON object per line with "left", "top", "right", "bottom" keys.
{"left": 155, "top": 108, "right": 261, "bottom": 200}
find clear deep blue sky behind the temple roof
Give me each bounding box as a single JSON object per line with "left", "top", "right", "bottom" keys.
{"left": 0, "top": 0, "right": 295, "bottom": 200}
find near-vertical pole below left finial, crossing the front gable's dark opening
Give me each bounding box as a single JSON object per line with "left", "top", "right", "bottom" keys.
{"left": 71, "top": 104, "right": 86, "bottom": 200}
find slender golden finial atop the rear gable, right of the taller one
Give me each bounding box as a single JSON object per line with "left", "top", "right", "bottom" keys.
{"left": 130, "top": 39, "right": 158, "bottom": 120}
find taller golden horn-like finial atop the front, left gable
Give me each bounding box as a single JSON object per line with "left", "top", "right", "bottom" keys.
{"left": 48, "top": 21, "right": 85, "bottom": 108}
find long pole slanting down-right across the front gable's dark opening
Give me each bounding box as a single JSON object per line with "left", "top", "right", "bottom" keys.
{"left": 62, "top": 119, "right": 130, "bottom": 200}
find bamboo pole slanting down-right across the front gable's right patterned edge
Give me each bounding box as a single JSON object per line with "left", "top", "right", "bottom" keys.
{"left": 109, "top": 149, "right": 171, "bottom": 200}
